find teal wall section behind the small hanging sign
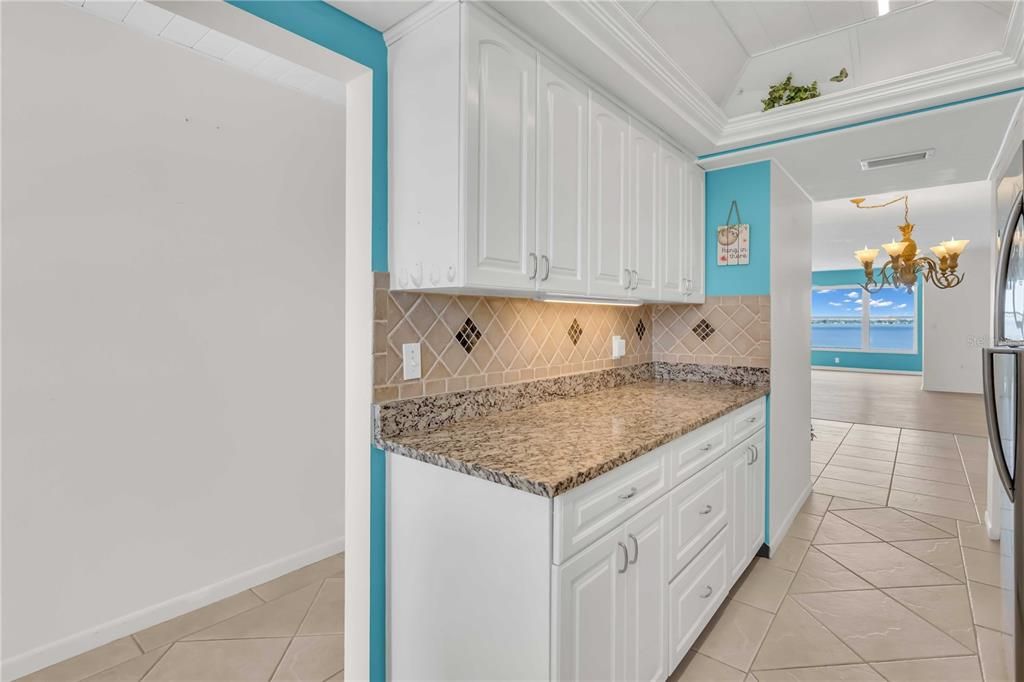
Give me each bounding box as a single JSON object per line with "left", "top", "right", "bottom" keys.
{"left": 705, "top": 161, "right": 771, "bottom": 296}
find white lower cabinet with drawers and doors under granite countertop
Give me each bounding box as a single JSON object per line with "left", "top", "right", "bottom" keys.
{"left": 387, "top": 400, "right": 765, "bottom": 682}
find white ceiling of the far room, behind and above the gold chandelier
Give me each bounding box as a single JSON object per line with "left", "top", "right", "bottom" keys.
{"left": 811, "top": 182, "right": 994, "bottom": 270}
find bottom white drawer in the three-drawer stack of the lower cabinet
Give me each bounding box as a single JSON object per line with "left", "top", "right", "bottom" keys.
{"left": 669, "top": 530, "right": 729, "bottom": 670}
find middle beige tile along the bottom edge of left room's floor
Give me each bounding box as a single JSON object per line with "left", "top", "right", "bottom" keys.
{"left": 143, "top": 638, "right": 289, "bottom": 682}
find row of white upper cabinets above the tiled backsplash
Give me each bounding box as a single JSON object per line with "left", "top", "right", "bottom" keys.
{"left": 388, "top": 3, "right": 703, "bottom": 302}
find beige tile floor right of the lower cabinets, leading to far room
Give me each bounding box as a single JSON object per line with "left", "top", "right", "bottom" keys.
{"left": 670, "top": 420, "right": 1012, "bottom": 682}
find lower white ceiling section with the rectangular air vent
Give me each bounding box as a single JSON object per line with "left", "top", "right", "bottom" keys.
{"left": 700, "top": 95, "right": 1022, "bottom": 201}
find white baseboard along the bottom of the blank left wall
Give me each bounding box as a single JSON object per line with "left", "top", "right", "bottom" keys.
{"left": 0, "top": 537, "right": 345, "bottom": 682}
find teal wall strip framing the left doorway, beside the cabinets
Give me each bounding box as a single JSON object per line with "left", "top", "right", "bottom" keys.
{"left": 228, "top": 0, "right": 388, "bottom": 682}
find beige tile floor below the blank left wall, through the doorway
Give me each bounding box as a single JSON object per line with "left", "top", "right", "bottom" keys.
{"left": 18, "top": 554, "right": 345, "bottom": 682}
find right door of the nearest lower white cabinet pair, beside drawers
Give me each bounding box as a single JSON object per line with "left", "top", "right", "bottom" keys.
{"left": 625, "top": 498, "right": 669, "bottom": 682}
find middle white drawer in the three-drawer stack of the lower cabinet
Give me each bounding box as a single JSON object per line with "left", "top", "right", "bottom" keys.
{"left": 669, "top": 454, "right": 728, "bottom": 576}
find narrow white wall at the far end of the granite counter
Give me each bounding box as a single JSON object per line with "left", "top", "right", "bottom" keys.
{"left": 768, "top": 161, "right": 811, "bottom": 547}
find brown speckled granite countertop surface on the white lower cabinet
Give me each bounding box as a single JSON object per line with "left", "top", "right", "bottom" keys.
{"left": 381, "top": 380, "right": 768, "bottom": 498}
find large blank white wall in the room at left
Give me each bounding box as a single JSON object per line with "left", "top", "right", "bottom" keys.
{"left": 2, "top": 2, "right": 345, "bottom": 677}
